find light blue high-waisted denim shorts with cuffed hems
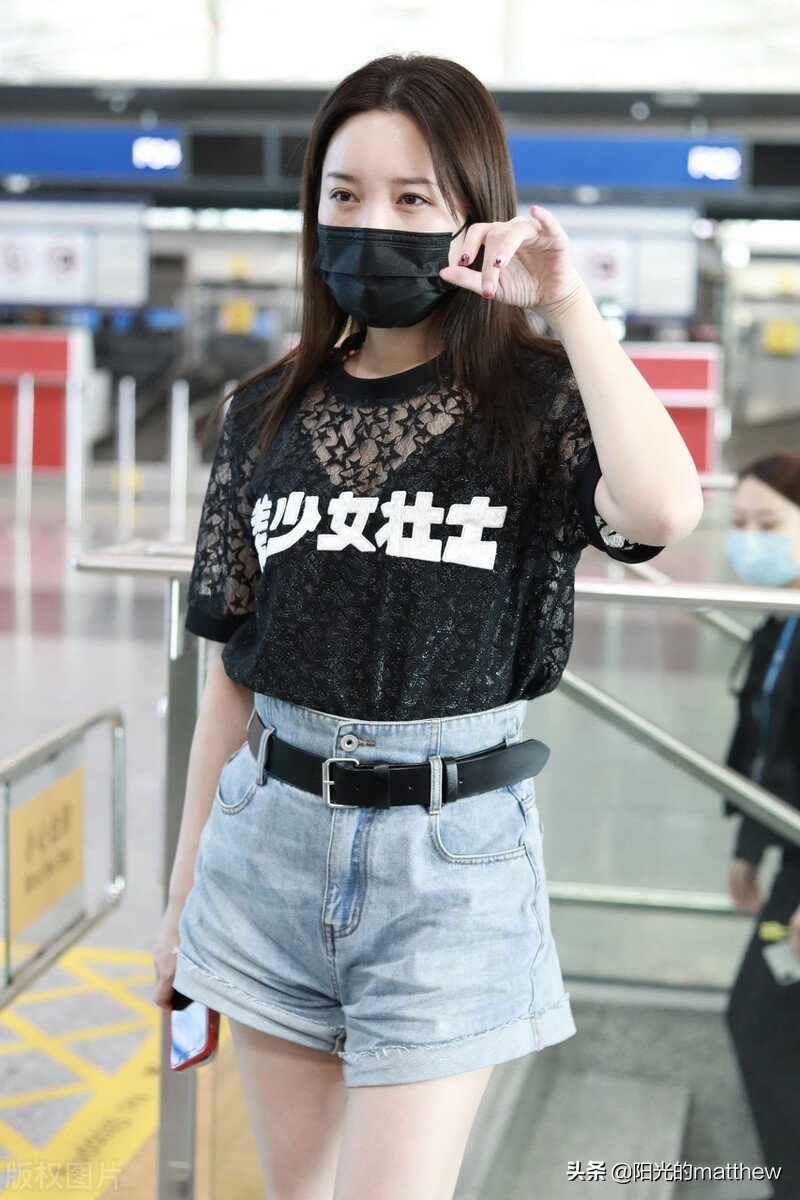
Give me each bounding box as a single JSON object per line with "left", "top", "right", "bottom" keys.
{"left": 175, "top": 695, "right": 575, "bottom": 1086}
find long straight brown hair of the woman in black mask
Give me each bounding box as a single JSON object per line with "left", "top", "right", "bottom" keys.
{"left": 241, "top": 54, "right": 566, "bottom": 478}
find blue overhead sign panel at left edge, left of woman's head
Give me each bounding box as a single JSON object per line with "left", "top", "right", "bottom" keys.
{"left": 0, "top": 125, "right": 184, "bottom": 179}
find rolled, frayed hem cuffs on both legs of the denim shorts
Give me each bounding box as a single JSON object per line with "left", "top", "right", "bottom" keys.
{"left": 175, "top": 952, "right": 576, "bottom": 1087}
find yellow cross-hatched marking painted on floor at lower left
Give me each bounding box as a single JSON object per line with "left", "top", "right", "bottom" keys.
{"left": 0, "top": 946, "right": 162, "bottom": 1200}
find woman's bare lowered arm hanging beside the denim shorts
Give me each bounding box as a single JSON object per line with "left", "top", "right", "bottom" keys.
{"left": 154, "top": 653, "right": 253, "bottom": 1008}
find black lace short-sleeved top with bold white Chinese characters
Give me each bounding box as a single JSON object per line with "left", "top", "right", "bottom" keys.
{"left": 186, "top": 353, "right": 660, "bottom": 720}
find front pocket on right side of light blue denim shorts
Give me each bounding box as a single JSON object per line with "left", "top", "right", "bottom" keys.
{"left": 428, "top": 784, "right": 530, "bottom": 864}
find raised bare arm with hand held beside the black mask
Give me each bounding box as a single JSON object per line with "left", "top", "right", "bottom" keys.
{"left": 441, "top": 206, "right": 703, "bottom": 546}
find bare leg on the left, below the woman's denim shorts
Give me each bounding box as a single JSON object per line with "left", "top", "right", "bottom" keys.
{"left": 229, "top": 1021, "right": 348, "bottom": 1200}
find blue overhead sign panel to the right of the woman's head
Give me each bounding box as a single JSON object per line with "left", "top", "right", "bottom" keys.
{"left": 509, "top": 133, "right": 742, "bottom": 191}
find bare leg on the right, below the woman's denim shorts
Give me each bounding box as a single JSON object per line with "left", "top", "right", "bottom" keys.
{"left": 332, "top": 1067, "right": 493, "bottom": 1200}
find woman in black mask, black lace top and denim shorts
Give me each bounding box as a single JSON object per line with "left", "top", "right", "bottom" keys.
{"left": 155, "top": 56, "right": 702, "bottom": 1200}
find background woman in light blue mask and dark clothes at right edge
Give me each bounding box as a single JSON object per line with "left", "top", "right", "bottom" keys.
{"left": 726, "top": 454, "right": 800, "bottom": 1200}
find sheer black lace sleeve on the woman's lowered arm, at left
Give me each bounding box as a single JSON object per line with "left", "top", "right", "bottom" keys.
{"left": 186, "top": 396, "right": 259, "bottom": 642}
